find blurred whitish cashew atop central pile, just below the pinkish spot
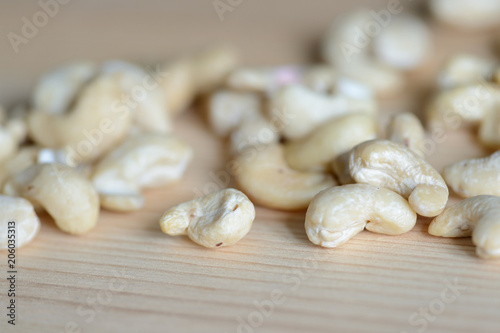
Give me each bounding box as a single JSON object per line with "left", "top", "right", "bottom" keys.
{"left": 269, "top": 85, "right": 377, "bottom": 139}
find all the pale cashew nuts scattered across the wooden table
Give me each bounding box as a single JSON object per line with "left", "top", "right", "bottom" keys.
{"left": 0, "top": 0, "right": 500, "bottom": 258}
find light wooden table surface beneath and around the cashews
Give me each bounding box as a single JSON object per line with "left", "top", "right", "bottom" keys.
{"left": 0, "top": 0, "right": 500, "bottom": 333}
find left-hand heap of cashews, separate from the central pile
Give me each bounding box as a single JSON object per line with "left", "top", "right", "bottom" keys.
{"left": 0, "top": 46, "right": 238, "bottom": 248}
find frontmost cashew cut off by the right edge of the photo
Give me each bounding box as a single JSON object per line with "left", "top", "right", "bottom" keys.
{"left": 429, "top": 195, "right": 500, "bottom": 259}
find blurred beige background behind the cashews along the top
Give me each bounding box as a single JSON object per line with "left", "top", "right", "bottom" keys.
{"left": 0, "top": 0, "right": 491, "bottom": 106}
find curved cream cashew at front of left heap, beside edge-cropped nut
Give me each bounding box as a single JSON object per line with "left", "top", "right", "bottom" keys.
{"left": 4, "top": 164, "right": 99, "bottom": 235}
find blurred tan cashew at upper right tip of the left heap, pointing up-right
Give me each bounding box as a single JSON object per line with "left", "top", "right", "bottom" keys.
{"left": 158, "top": 46, "right": 238, "bottom": 116}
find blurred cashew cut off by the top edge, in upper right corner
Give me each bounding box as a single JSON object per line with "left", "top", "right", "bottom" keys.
{"left": 429, "top": 0, "right": 500, "bottom": 29}
